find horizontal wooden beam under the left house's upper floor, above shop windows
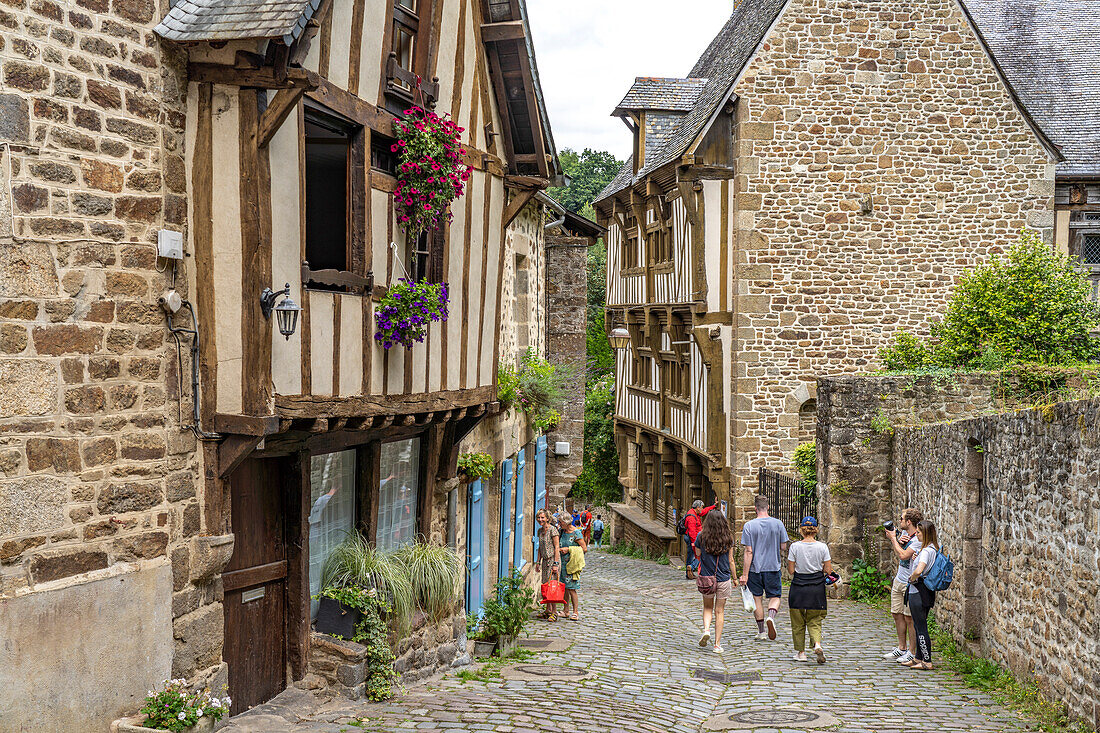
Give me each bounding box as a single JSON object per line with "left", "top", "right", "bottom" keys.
{"left": 275, "top": 385, "right": 496, "bottom": 416}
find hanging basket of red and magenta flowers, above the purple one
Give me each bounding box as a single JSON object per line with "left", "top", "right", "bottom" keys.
{"left": 391, "top": 107, "right": 470, "bottom": 238}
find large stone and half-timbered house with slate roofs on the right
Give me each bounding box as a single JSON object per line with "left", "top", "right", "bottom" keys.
{"left": 596, "top": 0, "right": 1100, "bottom": 550}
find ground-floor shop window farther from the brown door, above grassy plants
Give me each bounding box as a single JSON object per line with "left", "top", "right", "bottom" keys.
{"left": 375, "top": 438, "right": 420, "bottom": 550}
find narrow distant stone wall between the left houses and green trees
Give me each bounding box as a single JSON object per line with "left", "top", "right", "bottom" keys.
{"left": 546, "top": 236, "right": 590, "bottom": 505}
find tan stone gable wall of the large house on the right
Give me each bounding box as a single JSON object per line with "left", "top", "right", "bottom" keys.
{"left": 711, "top": 0, "right": 1054, "bottom": 505}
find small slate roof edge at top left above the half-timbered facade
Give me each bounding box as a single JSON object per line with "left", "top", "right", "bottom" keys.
{"left": 154, "top": 0, "right": 321, "bottom": 45}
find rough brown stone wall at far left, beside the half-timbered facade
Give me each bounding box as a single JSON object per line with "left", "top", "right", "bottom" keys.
{"left": 0, "top": 0, "right": 216, "bottom": 729}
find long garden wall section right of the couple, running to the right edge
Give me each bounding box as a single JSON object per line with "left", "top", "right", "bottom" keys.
{"left": 892, "top": 400, "right": 1100, "bottom": 726}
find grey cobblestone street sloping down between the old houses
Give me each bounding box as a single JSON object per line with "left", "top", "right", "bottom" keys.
{"left": 223, "top": 551, "right": 1024, "bottom": 733}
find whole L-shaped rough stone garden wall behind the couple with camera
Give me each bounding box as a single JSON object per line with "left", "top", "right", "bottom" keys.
{"left": 817, "top": 374, "right": 1100, "bottom": 725}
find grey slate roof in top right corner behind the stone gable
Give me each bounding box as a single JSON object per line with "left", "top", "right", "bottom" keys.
{"left": 964, "top": 0, "right": 1100, "bottom": 176}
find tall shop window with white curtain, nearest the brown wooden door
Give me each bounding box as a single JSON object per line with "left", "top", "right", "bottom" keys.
{"left": 309, "top": 450, "right": 355, "bottom": 616}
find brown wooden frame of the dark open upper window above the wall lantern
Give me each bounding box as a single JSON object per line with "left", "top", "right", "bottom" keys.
{"left": 298, "top": 100, "right": 374, "bottom": 295}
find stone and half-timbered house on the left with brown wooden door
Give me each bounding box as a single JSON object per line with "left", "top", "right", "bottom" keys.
{"left": 0, "top": 0, "right": 591, "bottom": 731}
